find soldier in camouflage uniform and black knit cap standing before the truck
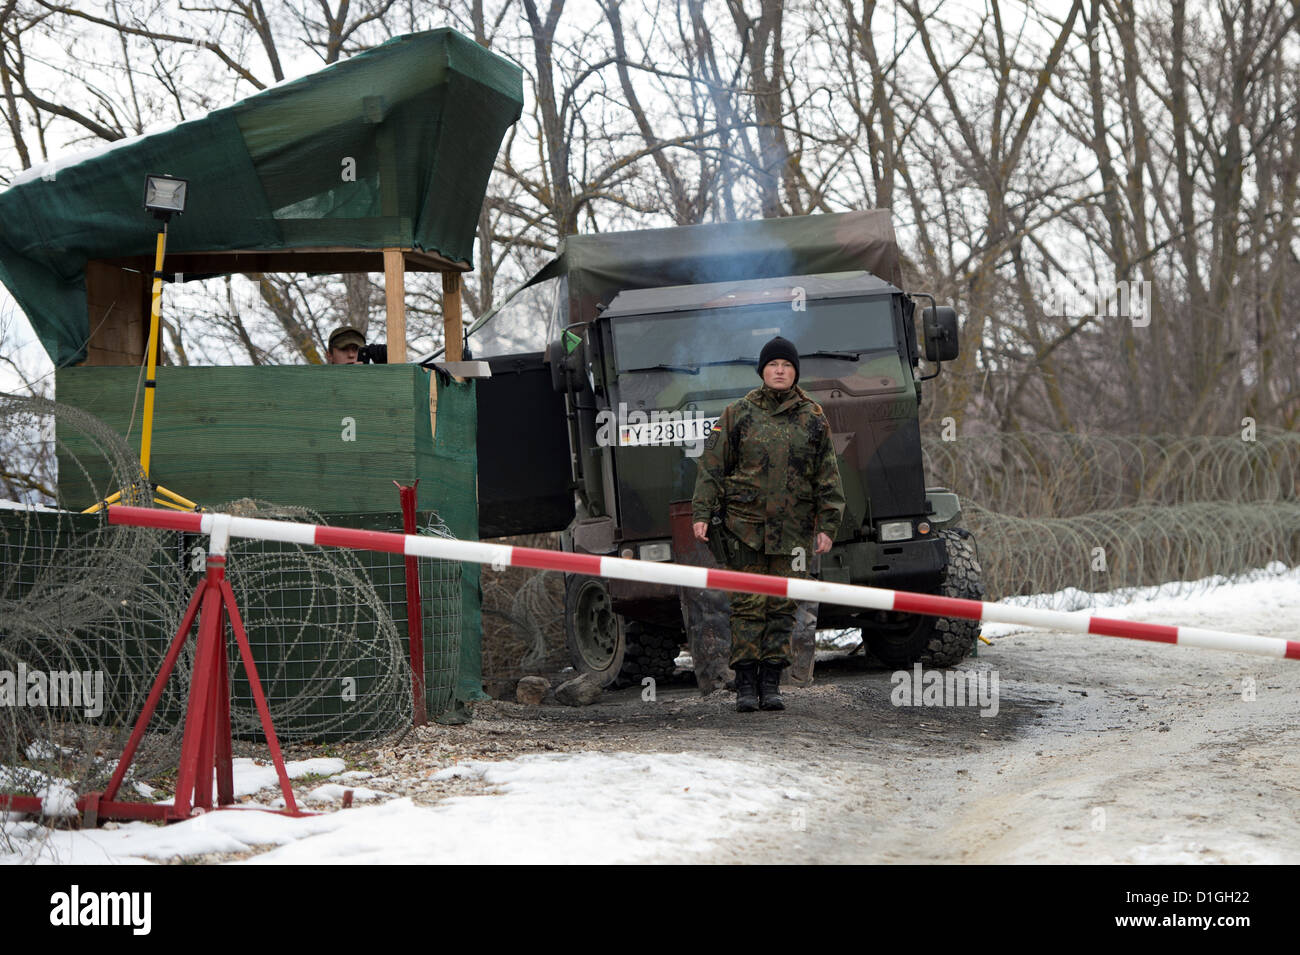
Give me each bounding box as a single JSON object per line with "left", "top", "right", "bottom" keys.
{"left": 692, "top": 337, "right": 844, "bottom": 712}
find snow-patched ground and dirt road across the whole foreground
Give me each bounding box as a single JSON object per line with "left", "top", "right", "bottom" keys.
{"left": 0, "top": 569, "right": 1300, "bottom": 864}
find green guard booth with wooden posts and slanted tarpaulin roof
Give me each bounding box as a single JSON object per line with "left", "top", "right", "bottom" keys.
{"left": 0, "top": 30, "right": 523, "bottom": 732}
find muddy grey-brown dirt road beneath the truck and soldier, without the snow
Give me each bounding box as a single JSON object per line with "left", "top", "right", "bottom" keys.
{"left": 343, "top": 621, "right": 1300, "bottom": 863}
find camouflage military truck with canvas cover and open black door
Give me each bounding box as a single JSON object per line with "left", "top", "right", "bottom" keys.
{"left": 478, "top": 210, "right": 983, "bottom": 685}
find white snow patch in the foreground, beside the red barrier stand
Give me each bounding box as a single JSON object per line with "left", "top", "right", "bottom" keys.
{"left": 0, "top": 752, "right": 813, "bottom": 864}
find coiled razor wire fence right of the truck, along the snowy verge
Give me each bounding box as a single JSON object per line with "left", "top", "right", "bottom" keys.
{"left": 923, "top": 429, "right": 1300, "bottom": 609}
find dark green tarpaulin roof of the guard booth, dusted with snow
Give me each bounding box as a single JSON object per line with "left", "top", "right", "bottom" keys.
{"left": 0, "top": 30, "right": 523, "bottom": 365}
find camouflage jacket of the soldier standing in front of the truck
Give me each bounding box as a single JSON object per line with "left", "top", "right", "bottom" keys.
{"left": 692, "top": 385, "right": 844, "bottom": 554}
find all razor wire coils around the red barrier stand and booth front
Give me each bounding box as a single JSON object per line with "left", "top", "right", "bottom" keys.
{"left": 0, "top": 395, "right": 449, "bottom": 815}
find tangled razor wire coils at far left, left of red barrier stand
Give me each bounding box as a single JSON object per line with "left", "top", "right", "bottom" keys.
{"left": 0, "top": 395, "right": 186, "bottom": 795}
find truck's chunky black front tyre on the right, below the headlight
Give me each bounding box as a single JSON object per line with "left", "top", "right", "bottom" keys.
{"left": 863, "top": 528, "right": 984, "bottom": 667}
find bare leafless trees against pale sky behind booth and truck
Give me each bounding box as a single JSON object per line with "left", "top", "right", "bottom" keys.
{"left": 0, "top": 0, "right": 1300, "bottom": 441}
